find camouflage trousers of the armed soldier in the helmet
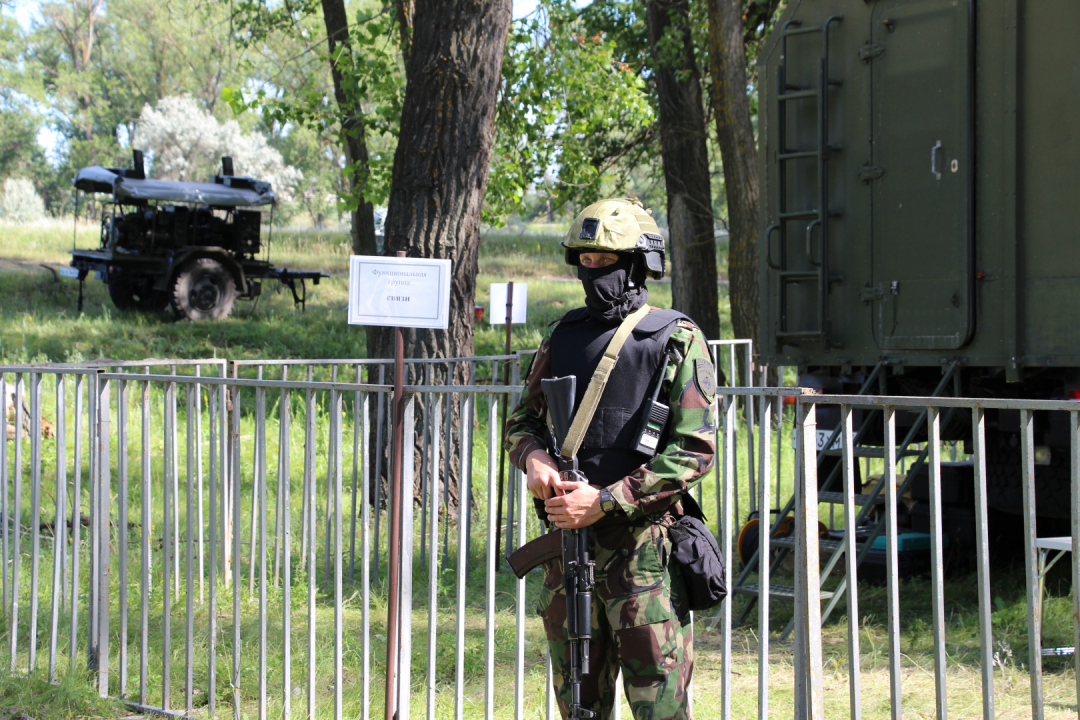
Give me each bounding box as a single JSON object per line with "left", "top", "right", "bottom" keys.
{"left": 538, "top": 524, "right": 693, "bottom": 720}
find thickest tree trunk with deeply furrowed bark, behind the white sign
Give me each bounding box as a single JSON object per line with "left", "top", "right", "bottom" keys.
{"left": 367, "top": 0, "right": 511, "bottom": 514}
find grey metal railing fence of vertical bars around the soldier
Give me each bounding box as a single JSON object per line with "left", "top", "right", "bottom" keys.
{"left": 0, "top": 358, "right": 1080, "bottom": 720}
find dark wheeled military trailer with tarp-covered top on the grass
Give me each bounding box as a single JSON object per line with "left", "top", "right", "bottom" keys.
{"left": 64, "top": 150, "right": 321, "bottom": 321}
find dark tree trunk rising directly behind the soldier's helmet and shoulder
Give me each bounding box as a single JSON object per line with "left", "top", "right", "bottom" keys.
{"left": 645, "top": 0, "right": 720, "bottom": 340}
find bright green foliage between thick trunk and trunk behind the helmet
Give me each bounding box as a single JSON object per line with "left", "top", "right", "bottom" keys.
{"left": 484, "top": 0, "right": 653, "bottom": 223}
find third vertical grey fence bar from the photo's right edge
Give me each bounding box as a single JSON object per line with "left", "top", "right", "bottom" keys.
{"left": 971, "top": 407, "right": 993, "bottom": 720}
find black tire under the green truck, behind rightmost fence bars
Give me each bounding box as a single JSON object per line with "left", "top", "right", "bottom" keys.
{"left": 986, "top": 432, "right": 1071, "bottom": 518}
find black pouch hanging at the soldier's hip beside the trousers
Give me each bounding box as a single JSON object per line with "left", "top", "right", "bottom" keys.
{"left": 667, "top": 494, "right": 728, "bottom": 610}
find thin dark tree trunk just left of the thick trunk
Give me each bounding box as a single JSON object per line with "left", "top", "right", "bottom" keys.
{"left": 322, "top": 0, "right": 378, "bottom": 255}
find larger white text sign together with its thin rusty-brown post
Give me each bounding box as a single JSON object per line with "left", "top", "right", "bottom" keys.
{"left": 345, "top": 252, "right": 450, "bottom": 720}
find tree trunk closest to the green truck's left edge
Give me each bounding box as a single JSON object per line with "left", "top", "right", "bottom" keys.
{"left": 707, "top": 0, "right": 759, "bottom": 351}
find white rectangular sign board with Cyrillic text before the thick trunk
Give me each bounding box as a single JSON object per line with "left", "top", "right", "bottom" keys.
{"left": 349, "top": 255, "right": 450, "bottom": 330}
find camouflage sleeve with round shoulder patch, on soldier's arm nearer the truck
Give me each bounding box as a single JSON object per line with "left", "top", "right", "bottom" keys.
{"left": 610, "top": 321, "right": 716, "bottom": 520}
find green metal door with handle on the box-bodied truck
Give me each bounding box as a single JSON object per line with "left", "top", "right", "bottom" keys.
{"left": 860, "top": 0, "right": 974, "bottom": 350}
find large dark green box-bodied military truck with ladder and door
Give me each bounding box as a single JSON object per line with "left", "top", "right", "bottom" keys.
{"left": 758, "top": 0, "right": 1080, "bottom": 517}
